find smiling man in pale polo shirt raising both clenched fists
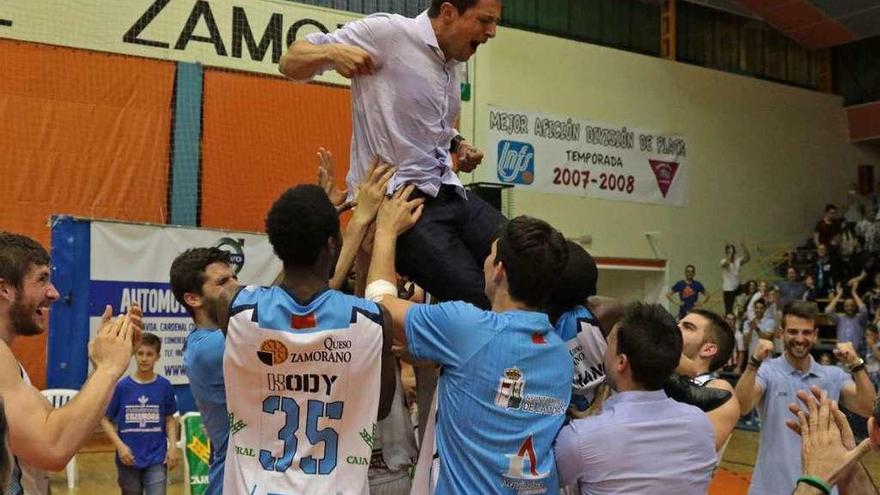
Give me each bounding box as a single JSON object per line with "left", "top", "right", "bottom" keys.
{"left": 735, "top": 301, "right": 875, "bottom": 495}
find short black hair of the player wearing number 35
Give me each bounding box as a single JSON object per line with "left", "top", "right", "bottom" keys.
{"left": 266, "top": 184, "right": 339, "bottom": 267}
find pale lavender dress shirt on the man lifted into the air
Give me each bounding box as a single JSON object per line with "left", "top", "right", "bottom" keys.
{"left": 305, "top": 12, "right": 464, "bottom": 197}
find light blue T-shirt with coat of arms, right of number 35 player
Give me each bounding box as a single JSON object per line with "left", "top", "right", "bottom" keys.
{"left": 406, "top": 302, "right": 572, "bottom": 495}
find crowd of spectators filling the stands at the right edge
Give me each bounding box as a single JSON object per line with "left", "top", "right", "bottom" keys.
{"left": 720, "top": 186, "right": 880, "bottom": 396}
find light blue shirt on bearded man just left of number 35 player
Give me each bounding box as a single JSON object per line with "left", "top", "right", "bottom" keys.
{"left": 183, "top": 328, "right": 229, "bottom": 495}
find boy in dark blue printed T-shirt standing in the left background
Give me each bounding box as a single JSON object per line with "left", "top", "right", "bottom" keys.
{"left": 101, "top": 333, "right": 180, "bottom": 495}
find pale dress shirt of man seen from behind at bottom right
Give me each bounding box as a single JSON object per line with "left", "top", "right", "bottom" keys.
{"left": 556, "top": 390, "right": 717, "bottom": 495}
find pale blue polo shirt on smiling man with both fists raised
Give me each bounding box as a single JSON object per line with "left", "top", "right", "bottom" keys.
{"left": 749, "top": 355, "right": 854, "bottom": 495}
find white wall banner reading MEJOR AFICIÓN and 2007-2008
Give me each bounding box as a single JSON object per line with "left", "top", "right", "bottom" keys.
{"left": 486, "top": 106, "right": 689, "bottom": 206}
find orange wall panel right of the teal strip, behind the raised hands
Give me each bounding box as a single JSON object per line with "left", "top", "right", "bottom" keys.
{"left": 201, "top": 70, "right": 351, "bottom": 232}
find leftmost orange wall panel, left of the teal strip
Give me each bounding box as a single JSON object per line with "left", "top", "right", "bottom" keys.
{"left": 0, "top": 40, "right": 175, "bottom": 387}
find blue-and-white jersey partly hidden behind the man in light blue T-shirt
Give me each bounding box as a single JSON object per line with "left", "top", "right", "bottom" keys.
{"left": 555, "top": 306, "right": 608, "bottom": 411}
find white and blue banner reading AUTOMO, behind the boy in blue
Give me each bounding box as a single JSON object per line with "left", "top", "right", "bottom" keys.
{"left": 89, "top": 221, "right": 281, "bottom": 385}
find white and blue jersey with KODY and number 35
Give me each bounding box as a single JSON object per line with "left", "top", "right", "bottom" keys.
{"left": 223, "top": 287, "right": 383, "bottom": 495}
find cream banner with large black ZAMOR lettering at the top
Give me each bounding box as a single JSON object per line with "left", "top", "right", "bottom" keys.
{"left": 0, "top": 0, "right": 360, "bottom": 85}
